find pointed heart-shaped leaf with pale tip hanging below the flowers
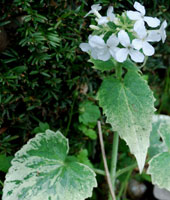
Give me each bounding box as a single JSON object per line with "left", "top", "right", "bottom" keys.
{"left": 97, "top": 71, "right": 155, "bottom": 172}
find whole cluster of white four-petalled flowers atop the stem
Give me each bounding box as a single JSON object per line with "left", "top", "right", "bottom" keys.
{"left": 80, "top": 2, "right": 167, "bottom": 63}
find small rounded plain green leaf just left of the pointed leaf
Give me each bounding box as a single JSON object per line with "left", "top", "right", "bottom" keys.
{"left": 79, "top": 101, "right": 100, "bottom": 125}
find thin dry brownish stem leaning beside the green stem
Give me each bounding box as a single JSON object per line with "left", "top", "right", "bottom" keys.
{"left": 97, "top": 121, "right": 116, "bottom": 200}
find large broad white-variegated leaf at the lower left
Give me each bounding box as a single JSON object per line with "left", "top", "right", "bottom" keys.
{"left": 2, "top": 130, "right": 97, "bottom": 200}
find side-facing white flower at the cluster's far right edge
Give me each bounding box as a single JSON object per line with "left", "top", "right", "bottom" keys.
{"left": 148, "top": 20, "right": 167, "bottom": 43}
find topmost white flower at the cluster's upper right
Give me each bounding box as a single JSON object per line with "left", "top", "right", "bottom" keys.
{"left": 127, "top": 2, "right": 160, "bottom": 28}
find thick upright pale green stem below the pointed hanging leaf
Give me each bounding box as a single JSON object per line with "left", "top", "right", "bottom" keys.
{"left": 109, "top": 132, "right": 119, "bottom": 200}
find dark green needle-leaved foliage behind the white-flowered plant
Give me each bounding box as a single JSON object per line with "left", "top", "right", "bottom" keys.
{"left": 0, "top": 0, "right": 170, "bottom": 199}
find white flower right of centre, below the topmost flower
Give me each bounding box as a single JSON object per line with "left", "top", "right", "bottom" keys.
{"left": 132, "top": 22, "right": 155, "bottom": 56}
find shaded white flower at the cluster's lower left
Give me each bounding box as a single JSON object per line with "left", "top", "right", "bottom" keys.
{"left": 80, "top": 35, "right": 119, "bottom": 61}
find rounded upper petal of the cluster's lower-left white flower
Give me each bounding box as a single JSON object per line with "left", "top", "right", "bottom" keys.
{"left": 89, "top": 35, "right": 106, "bottom": 49}
